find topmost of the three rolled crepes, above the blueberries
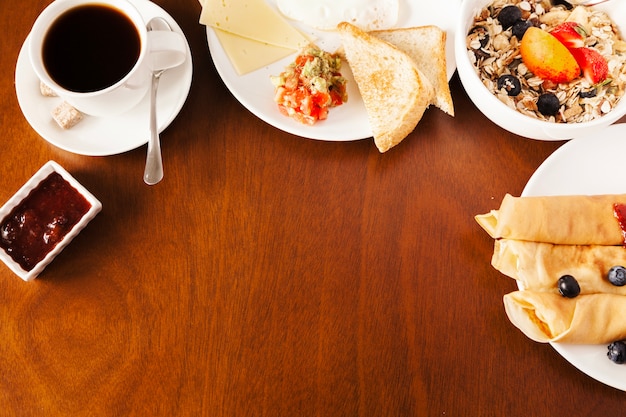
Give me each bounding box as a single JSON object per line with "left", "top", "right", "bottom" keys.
{"left": 475, "top": 194, "right": 626, "bottom": 245}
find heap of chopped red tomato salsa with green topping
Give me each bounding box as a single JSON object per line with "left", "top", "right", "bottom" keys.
{"left": 271, "top": 45, "right": 348, "bottom": 125}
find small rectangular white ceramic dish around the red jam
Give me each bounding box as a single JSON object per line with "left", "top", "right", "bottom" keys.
{"left": 0, "top": 161, "right": 102, "bottom": 281}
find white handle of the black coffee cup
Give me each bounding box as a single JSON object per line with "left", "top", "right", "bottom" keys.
{"left": 148, "top": 30, "right": 187, "bottom": 71}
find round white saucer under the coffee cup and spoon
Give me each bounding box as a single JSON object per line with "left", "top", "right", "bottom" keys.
{"left": 15, "top": 0, "right": 193, "bottom": 156}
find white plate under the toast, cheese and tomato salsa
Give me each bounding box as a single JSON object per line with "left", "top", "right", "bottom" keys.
{"left": 207, "top": 0, "right": 461, "bottom": 141}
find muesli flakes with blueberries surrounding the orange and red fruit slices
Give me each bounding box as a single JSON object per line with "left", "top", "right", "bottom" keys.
{"left": 467, "top": 0, "right": 626, "bottom": 123}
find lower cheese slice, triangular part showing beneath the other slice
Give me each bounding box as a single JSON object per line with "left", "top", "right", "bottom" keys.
{"left": 212, "top": 28, "right": 294, "bottom": 75}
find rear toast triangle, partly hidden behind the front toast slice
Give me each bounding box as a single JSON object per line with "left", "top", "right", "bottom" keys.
{"left": 370, "top": 25, "right": 454, "bottom": 116}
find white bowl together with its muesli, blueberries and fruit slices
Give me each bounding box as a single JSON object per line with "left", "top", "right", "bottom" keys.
{"left": 455, "top": 0, "right": 626, "bottom": 140}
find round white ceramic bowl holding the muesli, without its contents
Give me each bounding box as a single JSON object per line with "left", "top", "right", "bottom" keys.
{"left": 454, "top": 0, "right": 626, "bottom": 140}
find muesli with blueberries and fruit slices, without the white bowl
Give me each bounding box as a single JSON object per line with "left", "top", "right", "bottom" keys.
{"left": 467, "top": 0, "right": 626, "bottom": 123}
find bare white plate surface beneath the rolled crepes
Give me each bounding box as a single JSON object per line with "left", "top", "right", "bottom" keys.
{"left": 522, "top": 124, "right": 626, "bottom": 391}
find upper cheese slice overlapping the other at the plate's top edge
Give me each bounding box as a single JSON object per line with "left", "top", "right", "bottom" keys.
{"left": 200, "top": 0, "right": 309, "bottom": 50}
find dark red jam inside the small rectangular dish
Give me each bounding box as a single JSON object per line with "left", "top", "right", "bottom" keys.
{"left": 0, "top": 172, "right": 91, "bottom": 271}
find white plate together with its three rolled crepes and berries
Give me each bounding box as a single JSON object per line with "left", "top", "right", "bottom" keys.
{"left": 476, "top": 124, "right": 626, "bottom": 390}
